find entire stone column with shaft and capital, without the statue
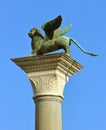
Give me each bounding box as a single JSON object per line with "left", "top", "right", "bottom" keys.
{"left": 12, "top": 53, "right": 82, "bottom": 130}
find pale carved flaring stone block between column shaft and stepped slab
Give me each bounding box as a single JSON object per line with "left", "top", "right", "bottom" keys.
{"left": 28, "top": 71, "right": 67, "bottom": 97}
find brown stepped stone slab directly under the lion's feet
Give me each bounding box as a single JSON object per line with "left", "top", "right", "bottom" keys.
{"left": 11, "top": 53, "right": 83, "bottom": 76}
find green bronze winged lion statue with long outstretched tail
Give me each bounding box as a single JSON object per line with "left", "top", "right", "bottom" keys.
{"left": 28, "top": 15, "right": 97, "bottom": 56}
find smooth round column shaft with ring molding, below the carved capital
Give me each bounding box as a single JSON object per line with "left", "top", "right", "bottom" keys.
{"left": 34, "top": 96, "right": 62, "bottom": 130}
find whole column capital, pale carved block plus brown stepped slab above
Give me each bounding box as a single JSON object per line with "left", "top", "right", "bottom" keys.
{"left": 11, "top": 53, "right": 83, "bottom": 97}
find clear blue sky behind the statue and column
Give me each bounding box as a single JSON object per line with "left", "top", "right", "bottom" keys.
{"left": 0, "top": 0, "right": 106, "bottom": 130}
